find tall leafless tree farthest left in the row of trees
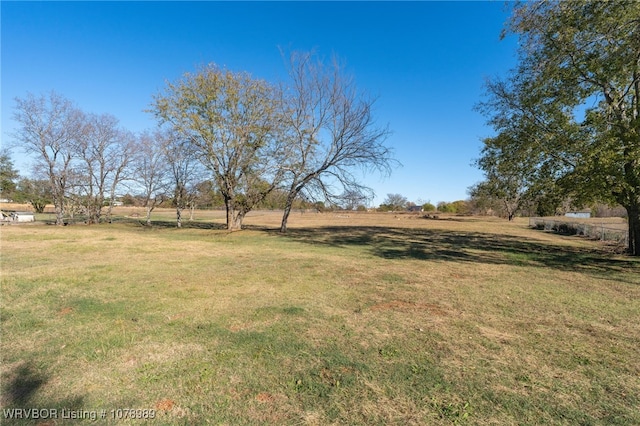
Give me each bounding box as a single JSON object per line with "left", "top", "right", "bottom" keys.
{"left": 13, "top": 92, "right": 83, "bottom": 225}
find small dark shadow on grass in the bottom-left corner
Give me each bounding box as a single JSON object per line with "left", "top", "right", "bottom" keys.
{"left": 0, "top": 362, "right": 84, "bottom": 425}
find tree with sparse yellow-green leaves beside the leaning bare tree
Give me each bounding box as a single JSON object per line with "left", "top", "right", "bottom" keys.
{"left": 151, "top": 64, "right": 284, "bottom": 230}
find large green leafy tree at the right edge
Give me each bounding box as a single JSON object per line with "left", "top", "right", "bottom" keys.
{"left": 480, "top": 1, "right": 640, "bottom": 255}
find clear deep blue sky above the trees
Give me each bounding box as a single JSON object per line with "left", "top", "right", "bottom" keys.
{"left": 1, "top": 1, "right": 517, "bottom": 205}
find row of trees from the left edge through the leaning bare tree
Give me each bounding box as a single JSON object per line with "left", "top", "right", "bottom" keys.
{"left": 1, "top": 52, "right": 397, "bottom": 232}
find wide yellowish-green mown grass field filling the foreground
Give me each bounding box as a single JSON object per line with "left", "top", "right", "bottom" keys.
{"left": 0, "top": 211, "right": 640, "bottom": 425}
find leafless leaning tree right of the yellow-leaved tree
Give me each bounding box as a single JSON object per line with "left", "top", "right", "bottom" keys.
{"left": 280, "top": 53, "right": 397, "bottom": 232}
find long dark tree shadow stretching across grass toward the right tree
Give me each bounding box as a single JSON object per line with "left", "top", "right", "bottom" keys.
{"left": 278, "top": 226, "right": 640, "bottom": 284}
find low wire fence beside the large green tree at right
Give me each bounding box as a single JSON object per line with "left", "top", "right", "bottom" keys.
{"left": 529, "top": 217, "right": 629, "bottom": 247}
